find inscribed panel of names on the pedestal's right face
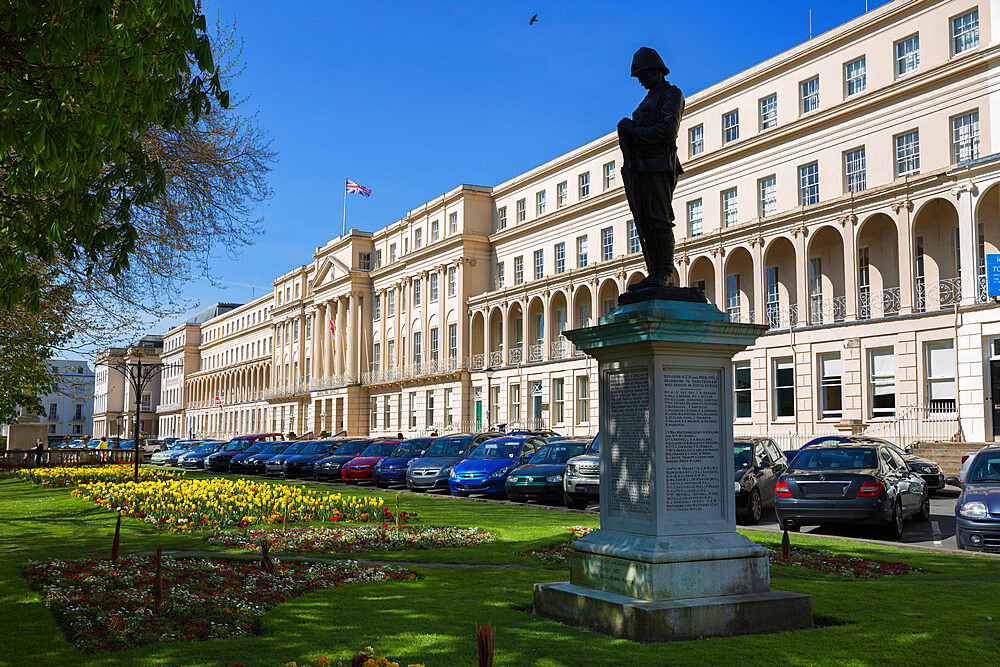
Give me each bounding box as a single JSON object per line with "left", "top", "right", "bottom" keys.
{"left": 663, "top": 371, "right": 720, "bottom": 521}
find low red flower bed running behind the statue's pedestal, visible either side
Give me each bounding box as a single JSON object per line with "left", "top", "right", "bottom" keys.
{"left": 521, "top": 526, "right": 924, "bottom": 579}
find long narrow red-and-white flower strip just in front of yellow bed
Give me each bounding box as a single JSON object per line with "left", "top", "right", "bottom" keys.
{"left": 208, "top": 526, "right": 496, "bottom": 553}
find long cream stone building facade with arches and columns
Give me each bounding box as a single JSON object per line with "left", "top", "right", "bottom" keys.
{"left": 113, "top": 0, "right": 1000, "bottom": 444}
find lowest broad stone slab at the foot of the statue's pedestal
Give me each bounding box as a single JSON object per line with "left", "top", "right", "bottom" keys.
{"left": 534, "top": 581, "right": 813, "bottom": 642}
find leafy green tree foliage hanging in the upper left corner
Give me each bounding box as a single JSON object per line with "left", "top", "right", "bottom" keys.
{"left": 0, "top": 0, "right": 229, "bottom": 309}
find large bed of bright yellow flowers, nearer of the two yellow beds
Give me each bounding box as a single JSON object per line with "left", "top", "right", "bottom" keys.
{"left": 72, "top": 478, "right": 392, "bottom": 532}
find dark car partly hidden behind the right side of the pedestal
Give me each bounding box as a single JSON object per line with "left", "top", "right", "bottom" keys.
{"left": 733, "top": 438, "right": 788, "bottom": 523}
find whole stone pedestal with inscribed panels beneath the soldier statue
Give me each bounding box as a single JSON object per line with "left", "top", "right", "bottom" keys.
{"left": 535, "top": 301, "right": 812, "bottom": 641}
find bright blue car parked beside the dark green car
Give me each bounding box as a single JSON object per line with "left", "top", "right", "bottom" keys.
{"left": 448, "top": 435, "right": 545, "bottom": 496}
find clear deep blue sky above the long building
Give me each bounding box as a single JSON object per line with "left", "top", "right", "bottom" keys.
{"left": 145, "top": 0, "right": 884, "bottom": 333}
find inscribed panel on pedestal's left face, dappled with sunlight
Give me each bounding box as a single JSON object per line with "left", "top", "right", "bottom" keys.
{"left": 607, "top": 370, "right": 653, "bottom": 515}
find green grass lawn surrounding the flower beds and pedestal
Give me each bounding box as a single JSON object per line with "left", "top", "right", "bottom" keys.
{"left": 0, "top": 477, "right": 1000, "bottom": 667}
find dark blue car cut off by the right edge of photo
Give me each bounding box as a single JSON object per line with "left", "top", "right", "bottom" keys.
{"left": 948, "top": 445, "right": 1000, "bottom": 553}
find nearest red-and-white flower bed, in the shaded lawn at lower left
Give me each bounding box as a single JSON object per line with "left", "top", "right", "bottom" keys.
{"left": 24, "top": 556, "right": 419, "bottom": 652}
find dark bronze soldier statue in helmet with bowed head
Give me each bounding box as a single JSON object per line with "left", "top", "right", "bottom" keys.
{"left": 618, "top": 46, "right": 705, "bottom": 303}
